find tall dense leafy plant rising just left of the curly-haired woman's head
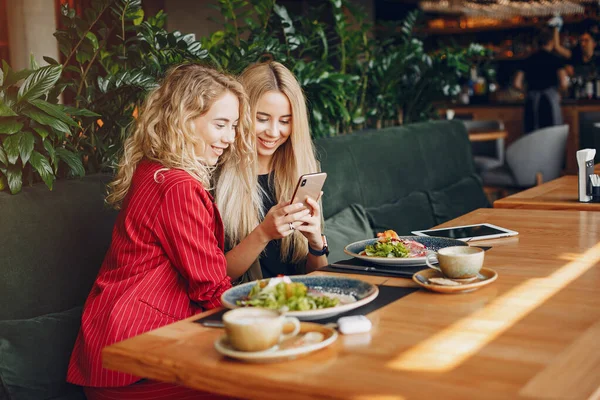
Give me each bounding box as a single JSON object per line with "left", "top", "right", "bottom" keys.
{"left": 54, "top": 0, "right": 207, "bottom": 171}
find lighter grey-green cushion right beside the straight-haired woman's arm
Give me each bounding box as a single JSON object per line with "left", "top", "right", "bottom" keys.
{"left": 324, "top": 204, "right": 373, "bottom": 263}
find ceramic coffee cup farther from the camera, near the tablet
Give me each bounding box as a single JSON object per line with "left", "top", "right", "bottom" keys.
{"left": 425, "top": 246, "right": 484, "bottom": 279}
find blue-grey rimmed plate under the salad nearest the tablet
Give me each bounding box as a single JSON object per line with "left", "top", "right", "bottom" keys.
{"left": 344, "top": 236, "right": 468, "bottom": 267}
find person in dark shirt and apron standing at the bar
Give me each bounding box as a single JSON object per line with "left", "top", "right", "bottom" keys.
{"left": 513, "top": 28, "right": 568, "bottom": 133}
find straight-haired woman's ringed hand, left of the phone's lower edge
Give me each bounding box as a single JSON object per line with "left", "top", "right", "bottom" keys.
{"left": 258, "top": 202, "right": 310, "bottom": 242}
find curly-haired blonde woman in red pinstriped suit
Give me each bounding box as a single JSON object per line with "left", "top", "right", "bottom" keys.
{"left": 67, "top": 64, "right": 255, "bottom": 400}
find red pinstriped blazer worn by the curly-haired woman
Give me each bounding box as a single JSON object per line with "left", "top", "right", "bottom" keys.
{"left": 67, "top": 161, "right": 231, "bottom": 387}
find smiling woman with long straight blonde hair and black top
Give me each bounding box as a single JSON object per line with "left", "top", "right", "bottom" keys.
{"left": 215, "top": 62, "right": 327, "bottom": 282}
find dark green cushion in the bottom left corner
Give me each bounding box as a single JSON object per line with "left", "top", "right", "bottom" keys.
{"left": 0, "top": 307, "right": 85, "bottom": 400}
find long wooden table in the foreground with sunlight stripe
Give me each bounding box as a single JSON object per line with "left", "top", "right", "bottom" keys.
{"left": 103, "top": 209, "right": 600, "bottom": 400}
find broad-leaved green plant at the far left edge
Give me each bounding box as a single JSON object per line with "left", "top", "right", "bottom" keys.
{"left": 0, "top": 59, "right": 88, "bottom": 194}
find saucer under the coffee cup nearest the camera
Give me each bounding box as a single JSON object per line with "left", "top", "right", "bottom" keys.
{"left": 215, "top": 322, "right": 338, "bottom": 363}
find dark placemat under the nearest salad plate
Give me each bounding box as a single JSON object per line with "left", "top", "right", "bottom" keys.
{"left": 194, "top": 286, "right": 419, "bottom": 326}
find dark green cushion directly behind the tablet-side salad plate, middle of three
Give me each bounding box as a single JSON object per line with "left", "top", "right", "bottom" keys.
{"left": 367, "top": 192, "right": 435, "bottom": 235}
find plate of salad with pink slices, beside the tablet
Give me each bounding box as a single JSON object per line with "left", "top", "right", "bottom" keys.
{"left": 344, "top": 230, "right": 468, "bottom": 267}
